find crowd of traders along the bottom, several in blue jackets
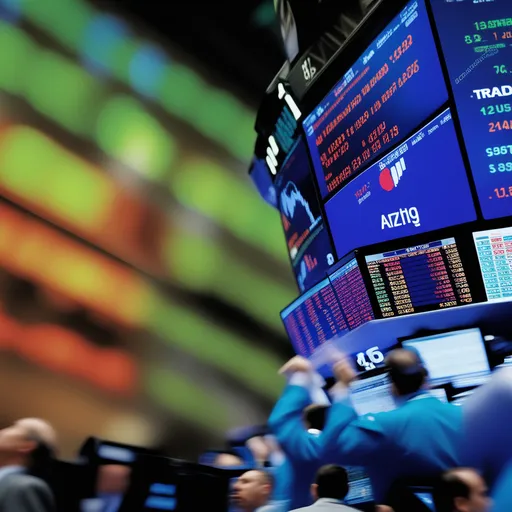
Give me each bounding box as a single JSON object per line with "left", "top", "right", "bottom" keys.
{"left": 0, "top": 349, "right": 512, "bottom": 512}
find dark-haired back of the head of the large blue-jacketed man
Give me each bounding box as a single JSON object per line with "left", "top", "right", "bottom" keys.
{"left": 386, "top": 349, "right": 428, "bottom": 396}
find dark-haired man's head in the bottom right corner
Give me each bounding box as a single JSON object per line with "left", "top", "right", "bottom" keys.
{"left": 434, "top": 468, "right": 491, "bottom": 512}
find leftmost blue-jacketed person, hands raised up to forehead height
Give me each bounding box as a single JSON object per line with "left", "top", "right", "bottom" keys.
{"left": 268, "top": 356, "right": 329, "bottom": 510}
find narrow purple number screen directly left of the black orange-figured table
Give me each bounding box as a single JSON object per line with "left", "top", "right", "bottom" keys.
{"left": 329, "top": 257, "right": 374, "bottom": 330}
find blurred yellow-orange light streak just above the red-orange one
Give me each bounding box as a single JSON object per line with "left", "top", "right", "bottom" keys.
{"left": 0, "top": 205, "right": 152, "bottom": 326}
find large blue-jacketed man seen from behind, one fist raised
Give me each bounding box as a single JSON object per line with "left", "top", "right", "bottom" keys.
{"left": 321, "top": 349, "right": 462, "bottom": 504}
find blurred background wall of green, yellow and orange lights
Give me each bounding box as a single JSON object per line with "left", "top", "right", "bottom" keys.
{"left": 0, "top": 0, "right": 297, "bottom": 457}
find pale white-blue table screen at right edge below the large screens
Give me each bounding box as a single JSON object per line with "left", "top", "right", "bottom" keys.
{"left": 473, "top": 227, "right": 512, "bottom": 301}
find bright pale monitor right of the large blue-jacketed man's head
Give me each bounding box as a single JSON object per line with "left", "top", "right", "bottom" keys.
{"left": 402, "top": 329, "right": 491, "bottom": 388}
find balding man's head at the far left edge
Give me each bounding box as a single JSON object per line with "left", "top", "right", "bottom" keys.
{"left": 0, "top": 418, "right": 57, "bottom": 470}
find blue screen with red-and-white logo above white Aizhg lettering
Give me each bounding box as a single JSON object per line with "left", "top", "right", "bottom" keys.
{"left": 325, "top": 110, "right": 476, "bottom": 255}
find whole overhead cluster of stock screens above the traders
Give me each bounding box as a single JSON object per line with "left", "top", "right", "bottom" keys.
{"left": 251, "top": 0, "right": 512, "bottom": 392}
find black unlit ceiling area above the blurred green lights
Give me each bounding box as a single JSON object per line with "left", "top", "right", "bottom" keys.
{"left": 102, "top": 0, "right": 285, "bottom": 105}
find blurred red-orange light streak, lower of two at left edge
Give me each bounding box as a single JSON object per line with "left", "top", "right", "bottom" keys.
{"left": 0, "top": 308, "right": 138, "bottom": 395}
